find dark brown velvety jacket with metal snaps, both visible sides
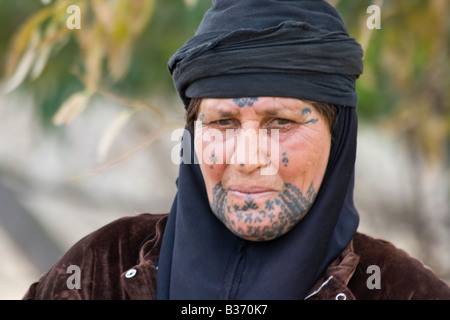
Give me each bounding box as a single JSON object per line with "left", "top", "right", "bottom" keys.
{"left": 24, "top": 214, "right": 450, "bottom": 300}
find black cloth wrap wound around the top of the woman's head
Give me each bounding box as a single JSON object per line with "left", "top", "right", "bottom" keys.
{"left": 169, "top": 0, "right": 362, "bottom": 107}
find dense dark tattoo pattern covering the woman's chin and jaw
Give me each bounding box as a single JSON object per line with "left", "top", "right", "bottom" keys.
{"left": 210, "top": 182, "right": 317, "bottom": 241}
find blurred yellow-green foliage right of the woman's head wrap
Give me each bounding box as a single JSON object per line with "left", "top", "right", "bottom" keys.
{"left": 338, "top": 0, "right": 450, "bottom": 165}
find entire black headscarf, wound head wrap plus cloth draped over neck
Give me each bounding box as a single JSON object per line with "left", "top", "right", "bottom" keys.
{"left": 157, "top": 0, "right": 362, "bottom": 299}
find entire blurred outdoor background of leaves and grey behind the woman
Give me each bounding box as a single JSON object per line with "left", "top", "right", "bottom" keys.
{"left": 0, "top": 0, "right": 450, "bottom": 299}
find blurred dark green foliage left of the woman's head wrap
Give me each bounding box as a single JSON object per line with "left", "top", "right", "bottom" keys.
{"left": 0, "top": 0, "right": 210, "bottom": 125}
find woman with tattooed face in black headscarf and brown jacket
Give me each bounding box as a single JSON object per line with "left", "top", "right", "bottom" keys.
{"left": 25, "top": 0, "right": 450, "bottom": 299}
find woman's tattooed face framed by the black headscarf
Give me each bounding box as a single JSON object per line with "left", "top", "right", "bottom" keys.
{"left": 195, "top": 97, "right": 331, "bottom": 241}
